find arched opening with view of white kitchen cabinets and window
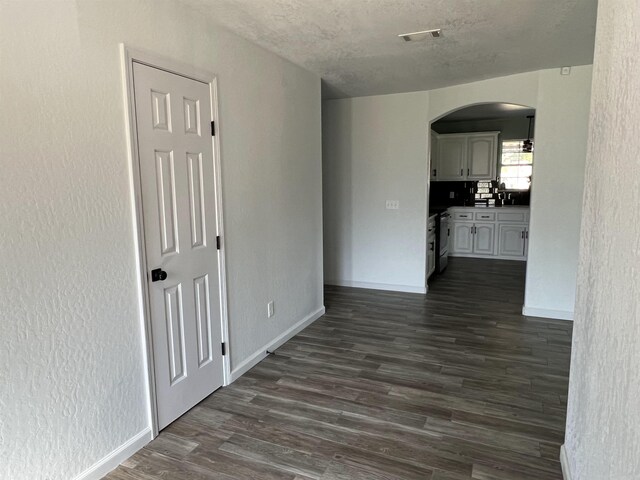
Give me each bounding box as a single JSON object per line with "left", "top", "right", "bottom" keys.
{"left": 426, "top": 102, "right": 535, "bottom": 296}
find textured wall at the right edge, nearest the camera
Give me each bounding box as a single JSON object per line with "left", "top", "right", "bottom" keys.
{"left": 565, "top": 0, "right": 640, "bottom": 480}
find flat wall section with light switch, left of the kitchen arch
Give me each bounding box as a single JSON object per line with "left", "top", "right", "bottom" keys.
{"left": 323, "top": 92, "right": 428, "bottom": 291}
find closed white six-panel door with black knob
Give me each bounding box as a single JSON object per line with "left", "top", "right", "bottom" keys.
{"left": 133, "top": 63, "right": 224, "bottom": 429}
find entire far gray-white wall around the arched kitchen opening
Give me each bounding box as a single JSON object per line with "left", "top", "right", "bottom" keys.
{"left": 323, "top": 66, "right": 591, "bottom": 318}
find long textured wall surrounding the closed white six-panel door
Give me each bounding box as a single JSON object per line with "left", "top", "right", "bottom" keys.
{"left": 0, "top": 0, "right": 322, "bottom": 480}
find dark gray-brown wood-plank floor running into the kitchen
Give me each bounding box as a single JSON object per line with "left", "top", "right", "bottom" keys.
{"left": 106, "top": 259, "right": 571, "bottom": 480}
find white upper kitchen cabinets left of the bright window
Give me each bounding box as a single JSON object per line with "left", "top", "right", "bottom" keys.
{"left": 429, "top": 132, "right": 500, "bottom": 182}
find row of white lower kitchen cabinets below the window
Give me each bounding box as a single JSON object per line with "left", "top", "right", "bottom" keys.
{"left": 449, "top": 207, "right": 529, "bottom": 260}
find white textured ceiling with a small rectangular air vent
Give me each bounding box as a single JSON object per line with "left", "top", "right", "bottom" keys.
{"left": 180, "top": 0, "right": 597, "bottom": 98}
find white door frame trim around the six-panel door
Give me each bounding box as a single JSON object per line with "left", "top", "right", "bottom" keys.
{"left": 120, "top": 43, "right": 231, "bottom": 438}
